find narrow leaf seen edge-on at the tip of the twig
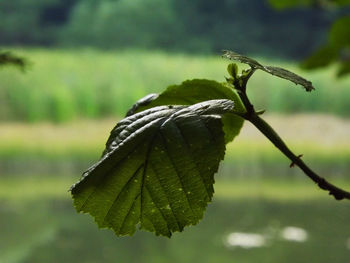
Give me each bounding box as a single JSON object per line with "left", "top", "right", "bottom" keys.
{"left": 223, "top": 50, "right": 315, "bottom": 91}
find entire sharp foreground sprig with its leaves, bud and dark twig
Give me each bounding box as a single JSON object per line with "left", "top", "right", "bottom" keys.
{"left": 71, "top": 51, "right": 330, "bottom": 237}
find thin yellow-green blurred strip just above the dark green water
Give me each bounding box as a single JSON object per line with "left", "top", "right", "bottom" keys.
{"left": 0, "top": 175, "right": 350, "bottom": 202}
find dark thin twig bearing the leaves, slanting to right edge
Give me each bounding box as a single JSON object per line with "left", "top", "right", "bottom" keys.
{"left": 235, "top": 69, "right": 350, "bottom": 200}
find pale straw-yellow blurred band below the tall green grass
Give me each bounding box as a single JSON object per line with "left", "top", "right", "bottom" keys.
{"left": 0, "top": 114, "right": 350, "bottom": 159}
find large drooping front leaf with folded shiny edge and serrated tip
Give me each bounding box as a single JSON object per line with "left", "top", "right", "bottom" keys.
{"left": 71, "top": 100, "right": 234, "bottom": 237}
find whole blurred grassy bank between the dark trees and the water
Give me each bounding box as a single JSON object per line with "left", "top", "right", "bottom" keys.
{"left": 0, "top": 49, "right": 350, "bottom": 202}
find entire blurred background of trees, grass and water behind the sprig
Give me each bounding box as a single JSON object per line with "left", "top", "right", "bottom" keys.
{"left": 0, "top": 0, "right": 350, "bottom": 263}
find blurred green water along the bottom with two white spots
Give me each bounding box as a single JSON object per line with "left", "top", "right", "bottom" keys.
{"left": 0, "top": 199, "right": 350, "bottom": 263}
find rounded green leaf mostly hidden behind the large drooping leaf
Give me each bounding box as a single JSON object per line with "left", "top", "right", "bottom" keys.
{"left": 136, "top": 79, "right": 245, "bottom": 143}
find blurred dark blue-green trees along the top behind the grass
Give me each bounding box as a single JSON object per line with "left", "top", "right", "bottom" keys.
{"left": 0, "top": 0, "right": 335, "bottom": 59}
